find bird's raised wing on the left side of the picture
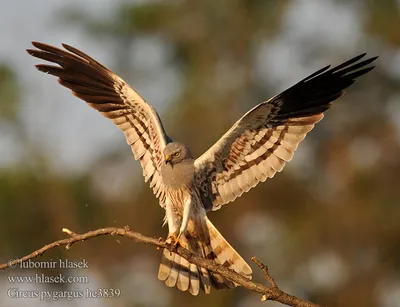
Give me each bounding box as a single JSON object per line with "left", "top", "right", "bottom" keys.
{"left": 27, "top": 42, "right": 169, "bottom": 207}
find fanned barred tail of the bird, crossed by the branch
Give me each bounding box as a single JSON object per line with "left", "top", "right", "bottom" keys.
{"left": 158, "top": 217, "right": 252, "bottom": 295}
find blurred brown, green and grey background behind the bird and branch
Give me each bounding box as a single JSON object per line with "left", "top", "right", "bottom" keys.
{"left": 0, "top": 0, "right": 400, "bottom": 307}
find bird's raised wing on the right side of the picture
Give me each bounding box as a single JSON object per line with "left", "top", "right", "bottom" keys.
{"left": 195, "top": 54, "right": 377, "bottom": 210}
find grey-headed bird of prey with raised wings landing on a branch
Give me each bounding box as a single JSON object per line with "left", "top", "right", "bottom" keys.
{"left": 27, "top": 42, "right": 377, "bottom": 295}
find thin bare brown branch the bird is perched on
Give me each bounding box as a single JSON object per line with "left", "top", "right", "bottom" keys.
{"left": 0, "top": 226, "right": 321, "bottom": 307}
